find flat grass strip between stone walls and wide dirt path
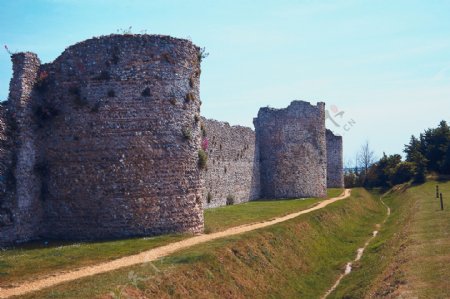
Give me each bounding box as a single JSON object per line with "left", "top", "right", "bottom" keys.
{"left": 0, "top": 189, "right": 342, "bottom": 287}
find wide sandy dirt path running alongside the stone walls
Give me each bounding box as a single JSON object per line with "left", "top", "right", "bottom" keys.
{"left": 0, "top": 189, "right": 351, "bottom": 298}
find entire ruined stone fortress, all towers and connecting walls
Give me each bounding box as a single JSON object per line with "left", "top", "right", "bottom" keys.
{"left": 0, "top": 34, "right": 343, "bottom": 245}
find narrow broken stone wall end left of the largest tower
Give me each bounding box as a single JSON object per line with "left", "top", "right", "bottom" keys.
{"left": 0, "top": 52, "right": 42, "bottom": 245}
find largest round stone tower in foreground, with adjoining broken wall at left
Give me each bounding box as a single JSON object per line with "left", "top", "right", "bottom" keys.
{"left": 0, "top": 35, "right": 203, "bottom": 246}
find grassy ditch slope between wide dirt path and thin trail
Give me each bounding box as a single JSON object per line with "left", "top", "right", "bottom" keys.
{"left": 18, "top": 190, "right": 385, "bottom": 298}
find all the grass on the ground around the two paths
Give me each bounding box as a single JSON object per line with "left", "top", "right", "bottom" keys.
{"left": 5, "top": 181, "right": 450, "bottom": 298}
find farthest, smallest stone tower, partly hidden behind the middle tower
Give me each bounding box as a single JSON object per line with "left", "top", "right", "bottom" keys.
{"left": 326, "top": 129, "right": 344, "bottom": 188}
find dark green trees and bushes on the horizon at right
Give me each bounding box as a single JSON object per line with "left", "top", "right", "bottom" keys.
{"left": 344, "top": 120, "right": 450, "bottom": 188}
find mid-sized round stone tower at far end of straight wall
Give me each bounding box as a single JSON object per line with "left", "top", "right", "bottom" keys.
{"left": 254, "top": 101, "right": 327, "bottom": 198}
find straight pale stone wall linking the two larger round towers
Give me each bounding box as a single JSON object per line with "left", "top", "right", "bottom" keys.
{"left": 202, "top": 118, "right": 260, "bottom": 208}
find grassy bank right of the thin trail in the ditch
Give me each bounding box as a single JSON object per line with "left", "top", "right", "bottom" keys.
{"left": 330, "top": 182, "right": 450, "bottom": 298}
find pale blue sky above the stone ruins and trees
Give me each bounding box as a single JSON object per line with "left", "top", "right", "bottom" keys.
{"left": 0, "top": 0, "right": 450, "bottom": 162}
